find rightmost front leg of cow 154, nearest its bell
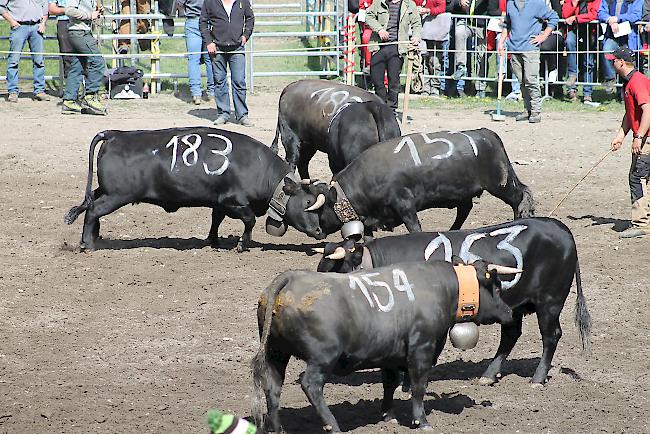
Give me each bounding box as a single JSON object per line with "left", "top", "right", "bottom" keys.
{"left": 408, "top": 343, "right": 442, "bottom": 430}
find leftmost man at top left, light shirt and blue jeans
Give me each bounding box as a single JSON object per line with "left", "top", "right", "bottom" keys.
{"left": 0, "top": 0, "right": 50, "bottom": 103}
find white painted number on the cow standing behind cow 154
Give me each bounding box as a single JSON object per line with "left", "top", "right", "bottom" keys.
{"left": 424, "top": 225, "right": 527, "bottom": 289}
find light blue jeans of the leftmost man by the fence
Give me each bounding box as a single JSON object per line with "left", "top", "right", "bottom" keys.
{"left": 7, "top": 24, "right": 45, "bottom": 94}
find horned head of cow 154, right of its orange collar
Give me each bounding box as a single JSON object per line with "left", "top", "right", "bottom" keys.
{"left": 472, "top": 261, "right": 521, "bottom": 324}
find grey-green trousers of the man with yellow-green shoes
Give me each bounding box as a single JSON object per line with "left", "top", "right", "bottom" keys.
{"left": 63, "top": 30, "right": 106, "bottom": 101}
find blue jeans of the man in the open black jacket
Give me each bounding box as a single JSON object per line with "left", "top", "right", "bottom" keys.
{"left": 212, "top": 47, "right": 248, "bottom": 121}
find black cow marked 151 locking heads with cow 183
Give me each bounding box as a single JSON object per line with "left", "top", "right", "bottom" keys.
{"left": 312, "top": 128, "right": 534, "bottom": 235}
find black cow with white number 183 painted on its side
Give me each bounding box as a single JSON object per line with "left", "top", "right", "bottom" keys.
{"left": 64, "top": 127, "right": 325, "bottom": 251}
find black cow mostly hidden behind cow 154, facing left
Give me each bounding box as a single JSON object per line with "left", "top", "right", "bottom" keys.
{"left": 318, "top": 218, "right": 591, "bottom": 385}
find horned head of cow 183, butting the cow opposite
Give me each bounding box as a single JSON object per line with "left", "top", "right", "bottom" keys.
{"left": 282, "top": 177, "right": 327, "bottom": 240}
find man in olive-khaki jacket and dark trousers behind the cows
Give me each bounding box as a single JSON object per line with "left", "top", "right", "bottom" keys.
{"left": 366, "top": 0, "right": 422, "bottom": 113}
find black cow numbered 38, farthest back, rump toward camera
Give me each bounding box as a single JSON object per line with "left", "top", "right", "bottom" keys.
{"left": 271, "top": 80, "right": 401, "bottom": 178}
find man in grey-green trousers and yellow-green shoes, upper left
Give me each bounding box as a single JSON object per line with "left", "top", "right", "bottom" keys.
{"left": 61, "top": 0, "right": 106, "bottom": 115}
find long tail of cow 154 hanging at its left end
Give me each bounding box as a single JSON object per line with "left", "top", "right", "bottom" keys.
{"left": 251, "top": 273, "right": 289, "bottom": 427}
